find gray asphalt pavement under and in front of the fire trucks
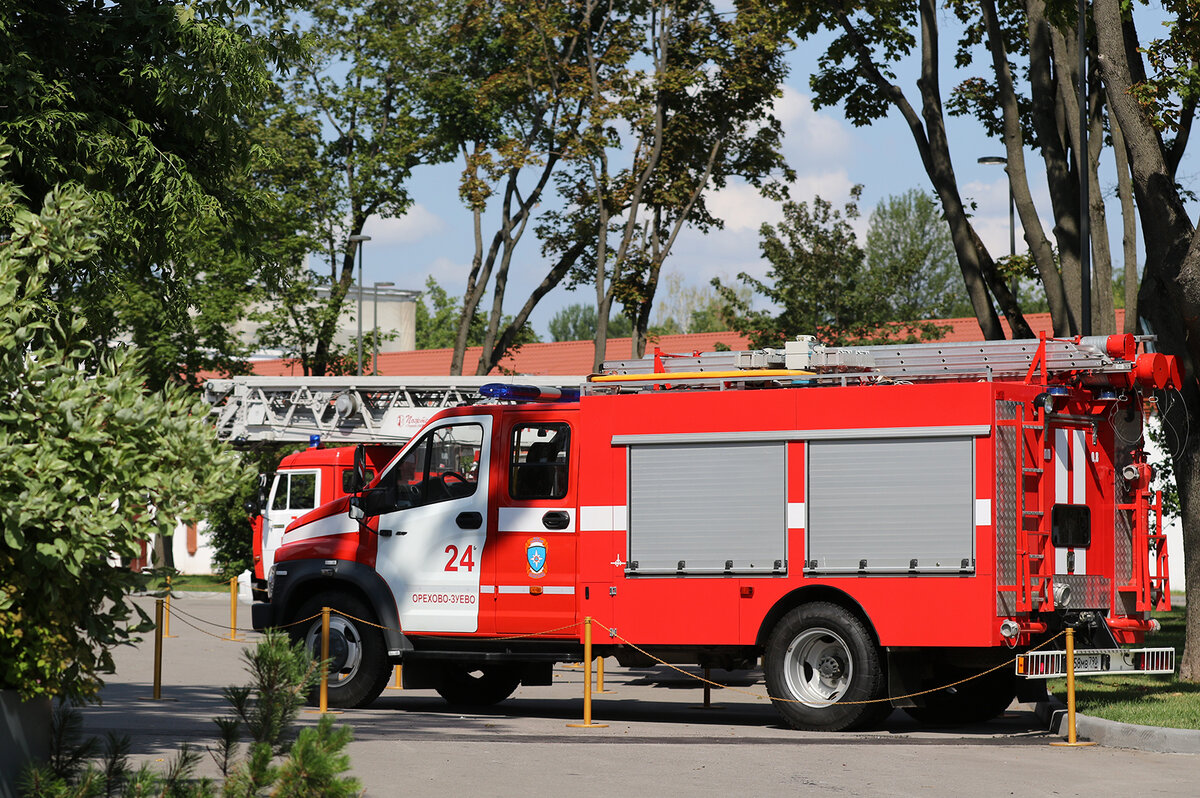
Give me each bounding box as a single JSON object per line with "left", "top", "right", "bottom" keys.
{"left": 83, "top": 594, "right": 1200, "bottom": 798}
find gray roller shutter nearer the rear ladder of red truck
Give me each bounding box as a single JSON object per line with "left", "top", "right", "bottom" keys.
{"left": 806, "top": 437, "right": 974, "bottom": 572}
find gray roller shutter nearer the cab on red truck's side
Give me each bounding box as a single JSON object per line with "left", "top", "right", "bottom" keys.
{"left": 629, "top": 442, "right": 787, "bottom": 574}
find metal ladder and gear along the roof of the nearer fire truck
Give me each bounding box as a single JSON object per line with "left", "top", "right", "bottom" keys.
{"left": 589, "top": 336, "right": 1148, "bottom": 392}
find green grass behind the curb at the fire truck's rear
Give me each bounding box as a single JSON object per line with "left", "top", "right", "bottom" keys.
{"left": 1049, "top": 608, "right": 1200, "bottom": 728}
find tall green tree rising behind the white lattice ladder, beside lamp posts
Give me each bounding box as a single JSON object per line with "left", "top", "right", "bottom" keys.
{"left": 254, "top": 0, "right": 442, "bottom": 376}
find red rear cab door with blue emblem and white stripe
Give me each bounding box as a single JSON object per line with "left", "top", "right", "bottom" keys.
{"left": 490, "top": 414, "right": 578, "bottom": 637}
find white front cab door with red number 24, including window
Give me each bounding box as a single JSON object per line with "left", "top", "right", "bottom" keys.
{"left": 376, "top": 415, "right": 492, "bottom": 632}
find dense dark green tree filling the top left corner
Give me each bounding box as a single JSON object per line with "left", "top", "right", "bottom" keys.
{"left": 0, "top": 0, "right": 295, "bottom": 386}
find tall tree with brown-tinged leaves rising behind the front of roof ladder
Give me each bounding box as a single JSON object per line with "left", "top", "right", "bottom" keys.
{"left": 556, "top": 0, "right": 792, "bottom": 368}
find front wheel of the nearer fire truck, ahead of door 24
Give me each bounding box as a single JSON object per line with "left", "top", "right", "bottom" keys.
{"left": 289, "top": 592, "right": 391, "bottom": 708}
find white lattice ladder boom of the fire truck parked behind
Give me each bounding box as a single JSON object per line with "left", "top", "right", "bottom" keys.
{"left": 204, "top": 376, "right": 583, "bottom": 445}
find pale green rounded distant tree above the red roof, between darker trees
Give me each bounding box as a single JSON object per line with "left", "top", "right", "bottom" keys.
{"left": 864, "top": 188, "right": 971, "bottom": 322}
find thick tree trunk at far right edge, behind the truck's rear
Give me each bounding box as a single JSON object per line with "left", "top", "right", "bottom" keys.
{"left": 1093, "top": 0, "right": 1200, "bottom": 682}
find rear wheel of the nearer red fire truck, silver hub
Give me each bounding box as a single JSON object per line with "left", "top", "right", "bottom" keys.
{"left": 763, "top": 601, "right": 892, "bottom": 732}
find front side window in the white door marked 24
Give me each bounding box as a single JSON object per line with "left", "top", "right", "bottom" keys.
{"left": 379, "top": 424, "right": 484, "bottom": 508}
